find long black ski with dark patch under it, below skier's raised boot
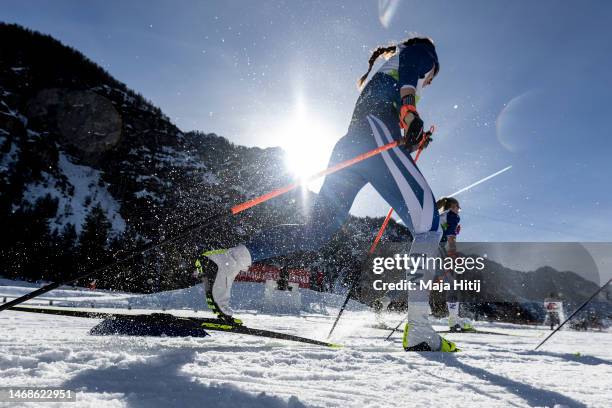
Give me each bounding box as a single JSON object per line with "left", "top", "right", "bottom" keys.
{"left": 10, "top": 306, "right": 342, "bottom": 348}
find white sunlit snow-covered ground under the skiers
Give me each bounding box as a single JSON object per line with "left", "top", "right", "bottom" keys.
{"left": 0, "top": 281, "right": 612, "bottom": 407}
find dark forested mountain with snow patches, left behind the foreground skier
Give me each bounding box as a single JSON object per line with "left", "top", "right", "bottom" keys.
{"left": 0, "top": 24, "right": 412, "bottom": 291}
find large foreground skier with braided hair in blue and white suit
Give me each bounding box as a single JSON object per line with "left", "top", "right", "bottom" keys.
{"left": 196, "top": 38, "right": 456, "bottom": 351}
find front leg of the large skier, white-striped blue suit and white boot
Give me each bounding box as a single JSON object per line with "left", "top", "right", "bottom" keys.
{"left": 362, "top": 115, "right": 456, "bottom": 351}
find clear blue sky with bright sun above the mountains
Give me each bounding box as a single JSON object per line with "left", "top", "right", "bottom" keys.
{"left": 0, "top": 0, "right": 612, "bottom": 241}
